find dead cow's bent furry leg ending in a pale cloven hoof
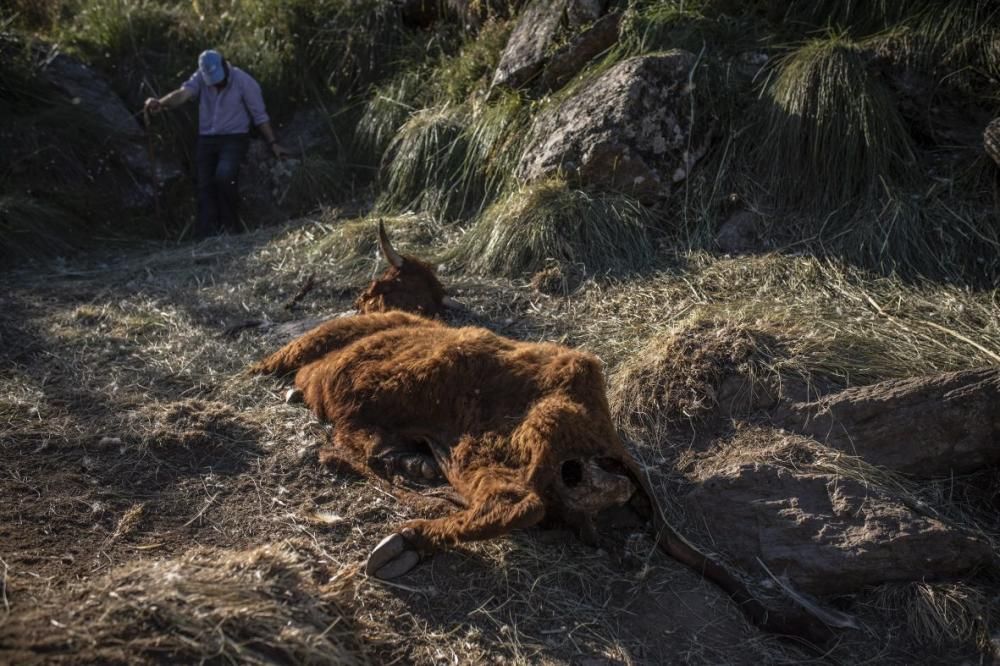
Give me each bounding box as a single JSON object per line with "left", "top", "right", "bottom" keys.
{"left": 365, "top": 484, "right": 545, "bottom": 578}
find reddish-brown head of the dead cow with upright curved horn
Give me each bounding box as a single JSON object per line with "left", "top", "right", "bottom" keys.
{"left": 354, "top": 220, "right": 457, "bottom": 317}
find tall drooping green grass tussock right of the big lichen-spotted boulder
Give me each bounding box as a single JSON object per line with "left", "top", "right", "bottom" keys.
{"left": 757, "top": 35, "right": 914, "bottom": 210}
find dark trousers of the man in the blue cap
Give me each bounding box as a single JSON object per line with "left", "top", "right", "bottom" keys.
{"left": 195, "top": 134, "right": 250, "bottom": 237}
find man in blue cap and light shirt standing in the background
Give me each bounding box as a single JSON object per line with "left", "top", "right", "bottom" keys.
{"left": 145, "top": 50, "right": 288, "bottom": 236}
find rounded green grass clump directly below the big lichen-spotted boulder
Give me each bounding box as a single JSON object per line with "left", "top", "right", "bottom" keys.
{"left": 456, "top": 179, "right": 653, "bottom": 277}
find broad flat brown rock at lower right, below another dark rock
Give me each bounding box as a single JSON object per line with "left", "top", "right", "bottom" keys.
{"left": 683, "top": 430, "right": 994, "bottom": 594}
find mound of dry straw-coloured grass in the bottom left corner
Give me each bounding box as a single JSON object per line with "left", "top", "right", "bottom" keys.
{"left": 6, "top": 545, "right": 369, "bottom": 665}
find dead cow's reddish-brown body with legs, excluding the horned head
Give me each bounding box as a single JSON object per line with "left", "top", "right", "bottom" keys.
{"left": 253, "top": 312, "right": 827, "bottom": 639}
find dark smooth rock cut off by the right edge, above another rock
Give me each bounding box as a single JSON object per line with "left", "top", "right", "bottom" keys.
{"left": 778, "top": 368, "right": 1000, "bottom": 477}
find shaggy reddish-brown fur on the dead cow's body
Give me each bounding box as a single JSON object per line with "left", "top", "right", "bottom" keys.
{"left": 254, "top": 312, "right": 628, "bottom": 548}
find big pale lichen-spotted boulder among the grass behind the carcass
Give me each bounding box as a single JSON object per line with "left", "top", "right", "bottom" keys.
{"left": 516, "top": 50, "right": 703, "bottom": 201}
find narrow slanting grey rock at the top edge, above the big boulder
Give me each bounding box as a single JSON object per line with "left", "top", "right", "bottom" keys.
{"left": 492, "top": 0, "right": 566, "bottom": 88}
